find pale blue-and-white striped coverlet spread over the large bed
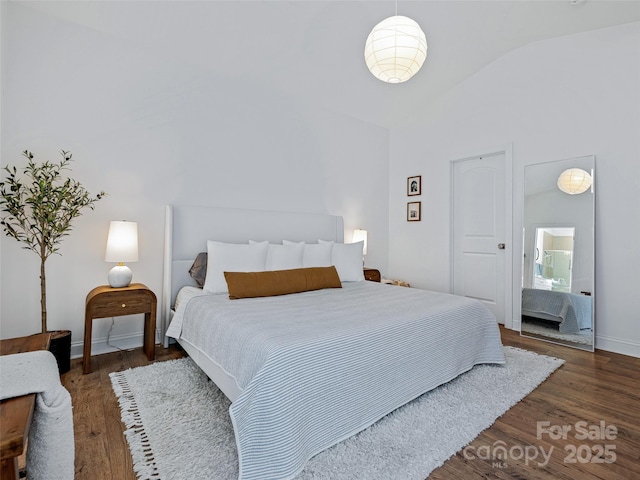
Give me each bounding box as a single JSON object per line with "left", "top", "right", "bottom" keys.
{"left": 168, "top": 281, "right": 505, "bottom": 480}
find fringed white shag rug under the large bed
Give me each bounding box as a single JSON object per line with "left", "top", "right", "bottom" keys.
{"left": 110, "top": 347, "right": 564, "bottom": 480}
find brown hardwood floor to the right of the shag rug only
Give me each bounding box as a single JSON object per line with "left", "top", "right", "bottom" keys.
{"left": 429, "top": 328, "right": 640, "bottom": 480}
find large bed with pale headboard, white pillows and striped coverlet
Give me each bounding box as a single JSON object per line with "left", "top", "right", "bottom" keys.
{"left": 163, "top": 206, "right": 504, "bottom": 480}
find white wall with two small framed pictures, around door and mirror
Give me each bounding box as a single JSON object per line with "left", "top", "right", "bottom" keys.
{"left": 389, "top": 23, "right": 640, "bottom": 356}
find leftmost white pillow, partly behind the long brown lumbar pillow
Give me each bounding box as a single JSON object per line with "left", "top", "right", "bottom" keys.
{"left": 202, "top": 240, "right": 269, "bottom": 293}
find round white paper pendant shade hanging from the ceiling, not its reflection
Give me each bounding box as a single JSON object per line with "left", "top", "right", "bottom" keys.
{"left": 364, "top": 15, "right": 427, "bottom": 83}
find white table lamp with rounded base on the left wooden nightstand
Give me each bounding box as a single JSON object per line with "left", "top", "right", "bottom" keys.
{"left": 104, "top": 221, "right": 138, "bottom": 288}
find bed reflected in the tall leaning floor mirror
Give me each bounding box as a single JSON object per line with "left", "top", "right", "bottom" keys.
{"left": 522, "top": 288, "right": 592, "bottom": 333}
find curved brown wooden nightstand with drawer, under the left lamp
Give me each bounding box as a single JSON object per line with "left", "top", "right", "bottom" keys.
{"left": 82, "top": 283, "right": 157, "bottom": 373}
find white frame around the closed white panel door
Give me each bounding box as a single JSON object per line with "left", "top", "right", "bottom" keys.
{"left": 449, "top": 143, "right": 520, "bottom": 329}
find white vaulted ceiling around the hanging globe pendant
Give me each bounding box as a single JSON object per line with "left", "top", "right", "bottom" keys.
{"left": 19, "top": 0, "right": 640, "bottom": 127}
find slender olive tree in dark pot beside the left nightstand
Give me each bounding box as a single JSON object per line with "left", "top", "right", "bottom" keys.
{"left": 0, "top": 150, "right": 105, "bottom": 373}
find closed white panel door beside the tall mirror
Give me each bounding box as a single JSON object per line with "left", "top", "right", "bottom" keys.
{"left": 452, "top": 152, "right": 507, "bottom": 323}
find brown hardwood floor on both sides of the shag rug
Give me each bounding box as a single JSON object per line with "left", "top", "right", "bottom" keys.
{"left": 62, "top": 329, "right": 640, "bottom": 480}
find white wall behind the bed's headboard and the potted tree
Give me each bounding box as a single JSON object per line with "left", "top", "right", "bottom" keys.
{"left": 0, "top": 2, "right": 389, "bottom": 353}
